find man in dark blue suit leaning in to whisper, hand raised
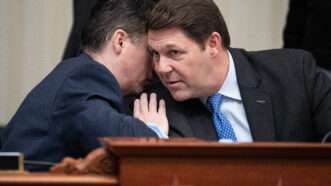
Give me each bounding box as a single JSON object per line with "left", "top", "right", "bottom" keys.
{"left": 1, "top": 0, "right": 168, "bottom": 171}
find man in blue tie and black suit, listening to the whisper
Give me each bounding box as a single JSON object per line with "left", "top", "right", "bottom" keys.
{"left": 148, "top": 0, "right": 331, "bottom": 142}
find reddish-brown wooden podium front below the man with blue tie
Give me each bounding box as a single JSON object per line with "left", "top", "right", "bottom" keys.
{"left": 105, "top": 139, "right": 331, "bottom": 186}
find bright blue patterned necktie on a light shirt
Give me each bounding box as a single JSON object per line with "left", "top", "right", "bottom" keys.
{"left": 207, "top": 93, "right": 237, "bottom": 141}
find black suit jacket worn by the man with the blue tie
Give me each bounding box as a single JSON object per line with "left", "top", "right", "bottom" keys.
{"left": 143, "top": 49, "right": 331, "bottom": 142}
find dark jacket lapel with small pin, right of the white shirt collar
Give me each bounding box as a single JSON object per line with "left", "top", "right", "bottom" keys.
{"left": 230, "top": 49, "right": 276, "bottom": 141}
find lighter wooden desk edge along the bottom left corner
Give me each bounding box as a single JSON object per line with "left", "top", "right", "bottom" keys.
{"left": 0, "top": 173, "right": 119, "bottom": 186}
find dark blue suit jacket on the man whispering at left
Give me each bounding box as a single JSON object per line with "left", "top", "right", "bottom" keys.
{"left": 2, "top": 54, "right": 155, "bottom": 170}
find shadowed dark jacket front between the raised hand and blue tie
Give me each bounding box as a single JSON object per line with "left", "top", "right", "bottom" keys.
{"left": 145, "top": 79, "right": 217, "bottom": 140}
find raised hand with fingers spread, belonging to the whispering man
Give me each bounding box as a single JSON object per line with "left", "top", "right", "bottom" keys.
{"left": 133, "top": 93, "right": 169, "bottom": 135}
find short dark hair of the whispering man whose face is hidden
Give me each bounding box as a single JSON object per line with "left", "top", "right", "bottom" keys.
{"left": 81, "top": 0, "right": 157, "bottom": 51}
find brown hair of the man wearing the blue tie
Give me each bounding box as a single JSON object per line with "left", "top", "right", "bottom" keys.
{"left": 148, "top": 0, "right": 230, "bottom": 48}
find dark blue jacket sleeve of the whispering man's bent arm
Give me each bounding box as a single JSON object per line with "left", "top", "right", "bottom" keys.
{"left": 52, "top": 64, "right": 156, "bottom": 152}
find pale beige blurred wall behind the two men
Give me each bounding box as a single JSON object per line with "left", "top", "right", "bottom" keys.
{"left": 0, "top": 0, "right": 288, "bottom": 125}
